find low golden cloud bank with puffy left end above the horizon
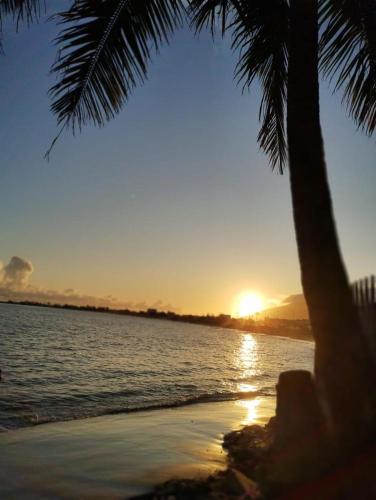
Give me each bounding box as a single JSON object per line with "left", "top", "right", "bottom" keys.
{"left": 0, "top": 256, "right": 176, "bottom": 312}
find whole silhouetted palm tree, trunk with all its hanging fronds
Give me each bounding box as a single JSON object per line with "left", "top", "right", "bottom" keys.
{"left": 0, "top": 0, "right": 376, "bottom": 446}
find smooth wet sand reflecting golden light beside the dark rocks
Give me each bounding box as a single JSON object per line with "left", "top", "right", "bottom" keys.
{"left": 0, "top": 397, "right": 275, "bottom": 499}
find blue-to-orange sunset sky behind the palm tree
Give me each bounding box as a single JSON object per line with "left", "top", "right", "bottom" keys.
{"left": 0, "top": 2, "right": 376, "bottom": 314}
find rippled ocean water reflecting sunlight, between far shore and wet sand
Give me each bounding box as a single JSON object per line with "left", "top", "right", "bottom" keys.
{"left": 0, "top": 304, "right": 313, "bottom": 430}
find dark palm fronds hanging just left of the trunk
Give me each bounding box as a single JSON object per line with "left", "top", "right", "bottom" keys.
{"left": 190, "top": 0, "right": 288, "bottom": 173}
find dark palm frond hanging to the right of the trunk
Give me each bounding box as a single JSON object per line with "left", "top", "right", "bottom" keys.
{"left": 320, "top": 0, "right": 376, "bottom": 135}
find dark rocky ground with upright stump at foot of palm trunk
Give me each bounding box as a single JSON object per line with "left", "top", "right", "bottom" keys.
{"left": 137, "top": 372, "right": 376, "bottom": 500}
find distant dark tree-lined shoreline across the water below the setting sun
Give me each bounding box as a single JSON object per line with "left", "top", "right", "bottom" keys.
{"left": 0, "top": 300, "right": 313, "bottom": 340}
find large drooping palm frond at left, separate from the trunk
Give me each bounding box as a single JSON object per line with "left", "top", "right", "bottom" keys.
{"left": 50, "top": 0, "right": 184, "bottom": 151}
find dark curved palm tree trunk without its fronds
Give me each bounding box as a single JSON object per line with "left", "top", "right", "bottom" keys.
{"left": 287, "top": 0, "right": 376, "bottom": 448}
